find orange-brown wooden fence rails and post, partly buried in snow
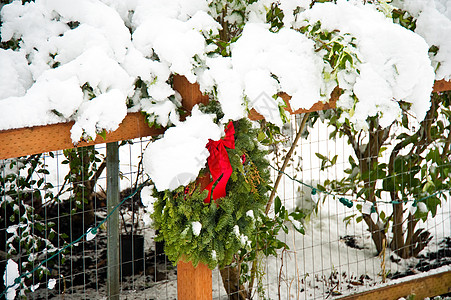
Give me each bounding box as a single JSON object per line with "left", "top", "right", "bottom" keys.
{"left": 0, "top": 76, "right": 451, "bottom": 300}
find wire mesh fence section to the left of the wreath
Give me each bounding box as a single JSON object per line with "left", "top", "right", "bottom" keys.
{"left": 1, "top": 140, "right": 175, "bottom": 299}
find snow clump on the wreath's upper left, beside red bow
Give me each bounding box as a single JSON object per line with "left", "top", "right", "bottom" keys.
{"left": 143, "top": 106, "right": 223, "bottom": 191}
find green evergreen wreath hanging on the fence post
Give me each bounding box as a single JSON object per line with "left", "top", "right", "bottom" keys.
{"left": 151, "top": 119, "right": 271, "bottom": 269}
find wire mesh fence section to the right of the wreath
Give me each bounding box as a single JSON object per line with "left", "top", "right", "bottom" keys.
{"left": 263, "top": 111, "right": 451, "bottom": 299}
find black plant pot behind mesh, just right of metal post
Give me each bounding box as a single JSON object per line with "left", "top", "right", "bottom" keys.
{"left": 121, "top": 234, "right": 144, "bottom": 279}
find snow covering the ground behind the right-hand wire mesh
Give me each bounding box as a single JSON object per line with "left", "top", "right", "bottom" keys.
{"left": 263, "top": 189, "right": 451, "bottom": 299}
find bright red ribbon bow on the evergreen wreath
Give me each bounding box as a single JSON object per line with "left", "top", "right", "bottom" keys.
{"left": 204, "top": 122, "right": 235, "bottom": 203}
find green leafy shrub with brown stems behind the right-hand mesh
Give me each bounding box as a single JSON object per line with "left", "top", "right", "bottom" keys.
{"left": 317, "top": 92, "right": 451, "bottom": 258}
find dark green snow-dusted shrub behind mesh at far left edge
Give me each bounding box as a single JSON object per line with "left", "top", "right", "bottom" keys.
{"left": 0, "top": 153, "right": 64, "bottom": 288}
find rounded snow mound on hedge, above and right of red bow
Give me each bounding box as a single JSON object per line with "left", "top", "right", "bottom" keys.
{"left": 198, "top": 23, "right": 327, "bottom": 127}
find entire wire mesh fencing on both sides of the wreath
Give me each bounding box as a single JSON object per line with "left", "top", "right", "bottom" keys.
{"left": 0, "top": 110, "right": 451, "bottom": 299}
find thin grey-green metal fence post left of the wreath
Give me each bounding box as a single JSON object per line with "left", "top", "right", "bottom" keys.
{"left": 106, "top": 142, "right": 120, "bottom": 300}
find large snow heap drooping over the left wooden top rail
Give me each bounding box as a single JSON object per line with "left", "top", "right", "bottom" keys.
{"left": 0, "top": 41, "right": 133, "bottom": 141}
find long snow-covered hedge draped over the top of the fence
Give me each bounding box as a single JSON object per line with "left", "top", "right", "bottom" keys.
{"left": 0, "top": 0, "right": 451, "bottom": 190}
